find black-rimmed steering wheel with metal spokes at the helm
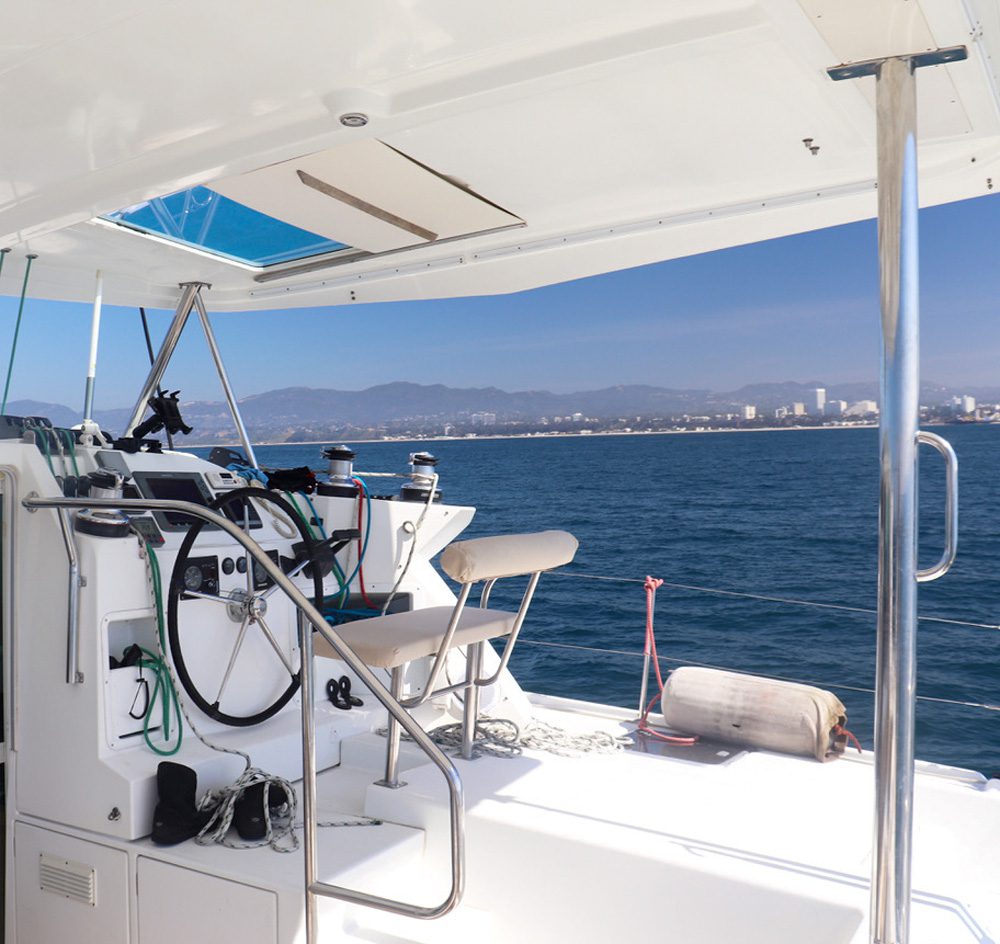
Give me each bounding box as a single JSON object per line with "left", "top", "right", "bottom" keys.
{"left": 167, "top": 488, "right": 323, "bottom": 727}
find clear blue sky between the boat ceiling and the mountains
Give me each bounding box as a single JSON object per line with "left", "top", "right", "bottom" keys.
{"left": 0, "top": 196, "right": 1000, "bottom": 409}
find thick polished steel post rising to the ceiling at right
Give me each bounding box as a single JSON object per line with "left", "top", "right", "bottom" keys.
{"left": 871, "top": 58, "right": 920, "bottom": 944}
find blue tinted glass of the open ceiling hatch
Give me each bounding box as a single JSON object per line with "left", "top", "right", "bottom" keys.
{"left": 104, "top": 187, "right": 348, "bottom": 266}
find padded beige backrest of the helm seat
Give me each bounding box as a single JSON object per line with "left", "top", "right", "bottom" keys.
{"left": 441, "top": 531, "right": 579, "bottom": 583}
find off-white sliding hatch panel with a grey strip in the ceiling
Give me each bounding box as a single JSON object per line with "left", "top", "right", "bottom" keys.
{"left": 208, "top": 138, "right": 521, "bottom": 252}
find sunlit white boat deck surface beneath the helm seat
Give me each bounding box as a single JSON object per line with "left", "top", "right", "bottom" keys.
{"left": 127, "top": 699, "right": 1000, "bottom": 944}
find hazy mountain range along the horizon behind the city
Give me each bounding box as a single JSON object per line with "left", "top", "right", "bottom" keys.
{"left": 9, "top": 381, "right": 1000, "bottom": 443}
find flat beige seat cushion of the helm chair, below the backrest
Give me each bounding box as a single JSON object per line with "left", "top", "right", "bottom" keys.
{"left": 314, "top": 606, "right": 515, "bottom": 669}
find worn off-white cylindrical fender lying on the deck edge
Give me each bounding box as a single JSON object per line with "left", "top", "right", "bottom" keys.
{"left": 662, "top": 666, "right": 847, "bottom": 761}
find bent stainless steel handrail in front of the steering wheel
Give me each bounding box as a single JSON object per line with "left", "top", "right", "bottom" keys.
{"left": 21, "top": 497, "right": 465, "bottom": 924}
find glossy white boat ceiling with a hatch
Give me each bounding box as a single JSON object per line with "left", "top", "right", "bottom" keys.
{"left": 0, "top": 0, "right": 1000, "bottom": 310}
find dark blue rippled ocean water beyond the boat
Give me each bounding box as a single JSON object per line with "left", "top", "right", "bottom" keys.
{"left": 199, "top": 426, "right": 1000, "bottom": 774}
